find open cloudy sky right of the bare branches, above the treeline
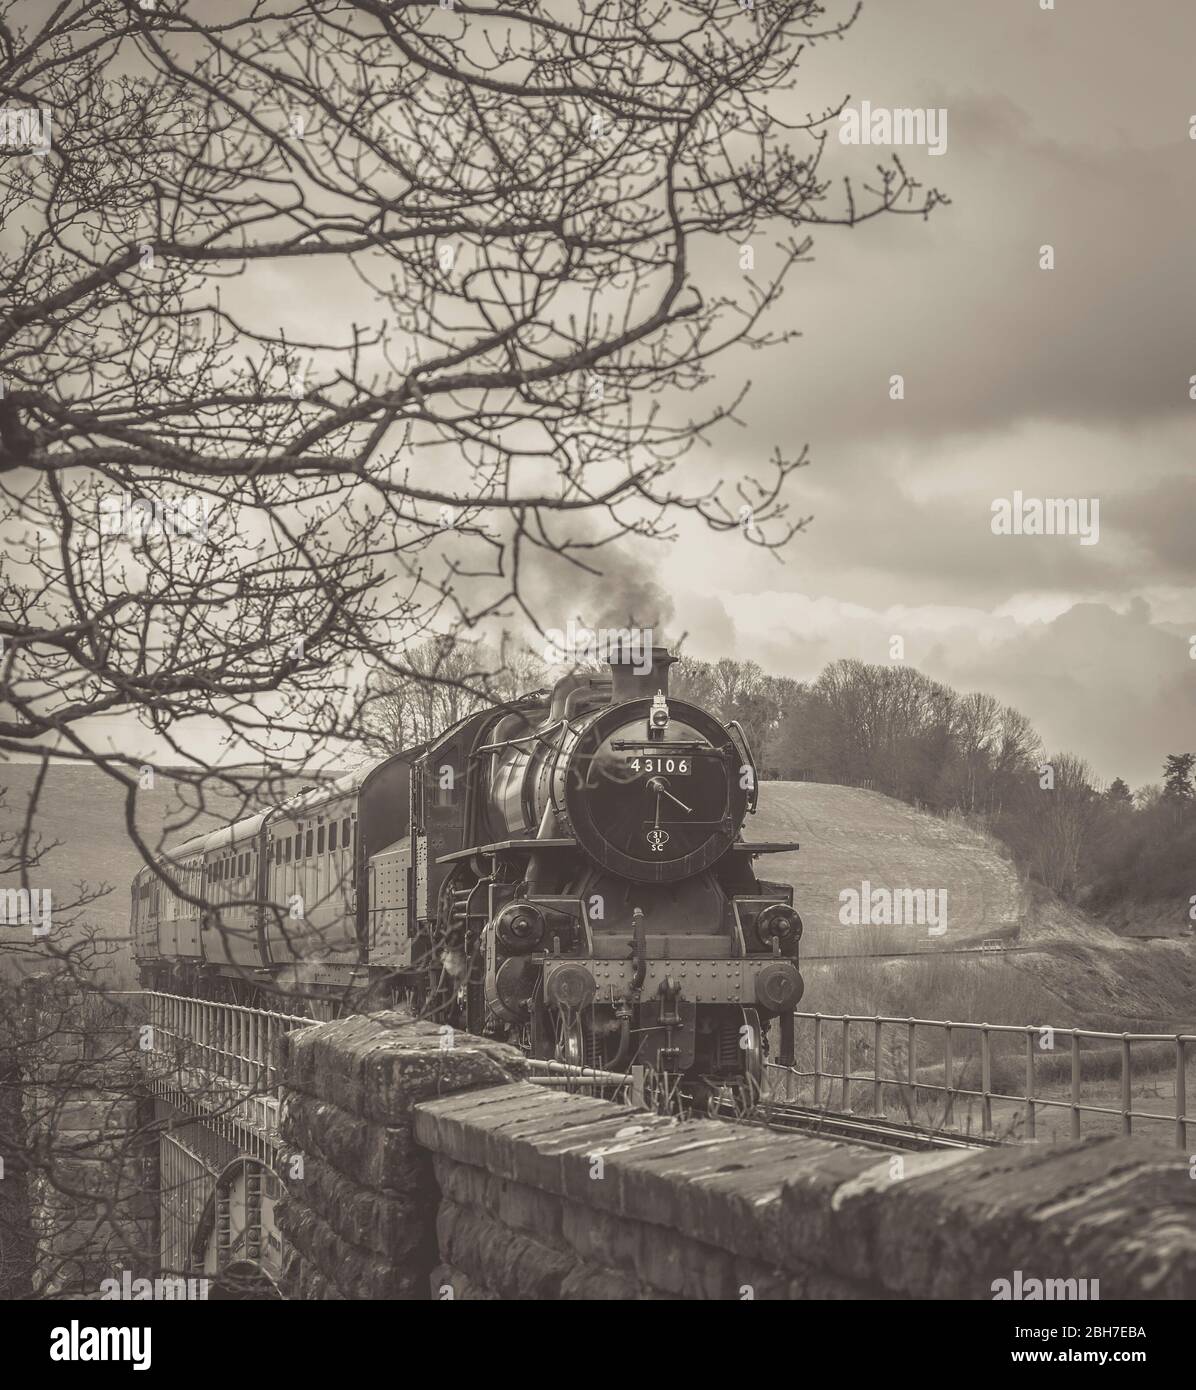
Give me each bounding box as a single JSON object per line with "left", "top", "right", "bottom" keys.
{"left": 556, "top": 0, "right": 1196, "bottom": 785}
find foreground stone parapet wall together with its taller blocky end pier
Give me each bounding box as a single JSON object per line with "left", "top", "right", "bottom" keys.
{"left": 280, "top": 1013, "right": 1196, "bottom": 1300}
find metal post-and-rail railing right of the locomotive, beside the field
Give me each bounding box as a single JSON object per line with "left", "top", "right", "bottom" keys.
{"left": 769, "top": 1013, "right": 1196, "bottom": 1148}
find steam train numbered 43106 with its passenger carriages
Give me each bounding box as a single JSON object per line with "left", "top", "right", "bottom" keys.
{"left": 132, "top": 646, "right": 802, "bottom": 1087}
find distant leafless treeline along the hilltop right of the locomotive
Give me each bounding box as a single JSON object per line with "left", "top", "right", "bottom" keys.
{"left": 672, "top": 657, "right": 1196, "bottom": 915}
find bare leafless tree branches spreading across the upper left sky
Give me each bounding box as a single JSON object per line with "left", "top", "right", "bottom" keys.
{"left": 0, "top": 0, "right": 939, "bottom": 861}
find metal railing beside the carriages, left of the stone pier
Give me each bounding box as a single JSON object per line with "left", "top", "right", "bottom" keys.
{"left": 140, "top": 990, "right": 313, "bottom": 1156}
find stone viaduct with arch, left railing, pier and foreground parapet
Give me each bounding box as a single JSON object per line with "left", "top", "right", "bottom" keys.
{"left": 16, "top": 995, "right": 1196, "bottom": 1300}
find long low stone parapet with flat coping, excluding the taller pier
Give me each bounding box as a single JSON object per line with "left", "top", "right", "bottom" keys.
{"left": 416, "top": 1084, "right": 1196, "bottom": 1300}
